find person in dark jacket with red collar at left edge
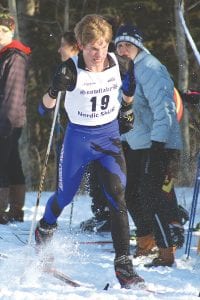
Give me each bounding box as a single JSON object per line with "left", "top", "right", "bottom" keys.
{"left": 0, "top": 14, "right": 31, "bottom": 224}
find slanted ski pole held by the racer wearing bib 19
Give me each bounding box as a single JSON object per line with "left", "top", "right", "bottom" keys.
{"left": 28, "top": 91, "right": 62, "bottom": 245}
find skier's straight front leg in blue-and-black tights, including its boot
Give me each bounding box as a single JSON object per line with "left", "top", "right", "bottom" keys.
{"left": 99, "top": 139, "right": 144, "bottom": 288}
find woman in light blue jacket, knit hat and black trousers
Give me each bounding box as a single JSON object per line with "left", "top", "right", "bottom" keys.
{"left": 115, "top": 25, "right": 184, "bottom": 266}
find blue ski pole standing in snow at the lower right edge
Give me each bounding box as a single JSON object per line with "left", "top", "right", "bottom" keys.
{"left": 185, "top": 154, "right": 200, "bottom": 259}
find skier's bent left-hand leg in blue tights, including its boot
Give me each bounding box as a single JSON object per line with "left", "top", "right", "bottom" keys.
{"left": 35, "top": 125, "right": 88, "bottom": 244}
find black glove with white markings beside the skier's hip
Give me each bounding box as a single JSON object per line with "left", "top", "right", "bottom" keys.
{"left": 118, "top": 100, "right": 134, "bottom": 134}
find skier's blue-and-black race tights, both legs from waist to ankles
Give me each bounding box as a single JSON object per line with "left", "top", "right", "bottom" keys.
{"left": 43, "top": 120, "right": 129, "bottom": 256}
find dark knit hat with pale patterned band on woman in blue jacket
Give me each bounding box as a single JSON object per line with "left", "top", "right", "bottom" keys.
{"left": 115, "top": 24, "right": 149, "bottom": 52}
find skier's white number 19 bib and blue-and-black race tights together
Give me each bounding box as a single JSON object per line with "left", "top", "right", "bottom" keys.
{"left": 40, "top": 53, "right": 132, "bottom": 256}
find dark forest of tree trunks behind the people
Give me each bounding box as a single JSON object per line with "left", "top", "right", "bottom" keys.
{"left": 0, "top": 0, "right": 200, "bottom": 192}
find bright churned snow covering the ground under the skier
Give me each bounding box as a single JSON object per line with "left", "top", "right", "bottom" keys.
{"left": 0, "top": 188, "right": 200, "bottom": 300}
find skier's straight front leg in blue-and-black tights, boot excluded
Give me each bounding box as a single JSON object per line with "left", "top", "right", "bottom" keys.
{"left": 99, "top": 141, "right": 129, "bottom": 256}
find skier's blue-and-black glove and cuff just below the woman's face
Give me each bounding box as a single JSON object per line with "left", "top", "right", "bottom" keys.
{"left": 122, "top": 60, "right": 135, "bottom": 97}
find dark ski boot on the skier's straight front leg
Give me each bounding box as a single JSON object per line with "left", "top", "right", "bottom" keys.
{"left": 114, "top": 255, "right": 144, "bottom": 289}
